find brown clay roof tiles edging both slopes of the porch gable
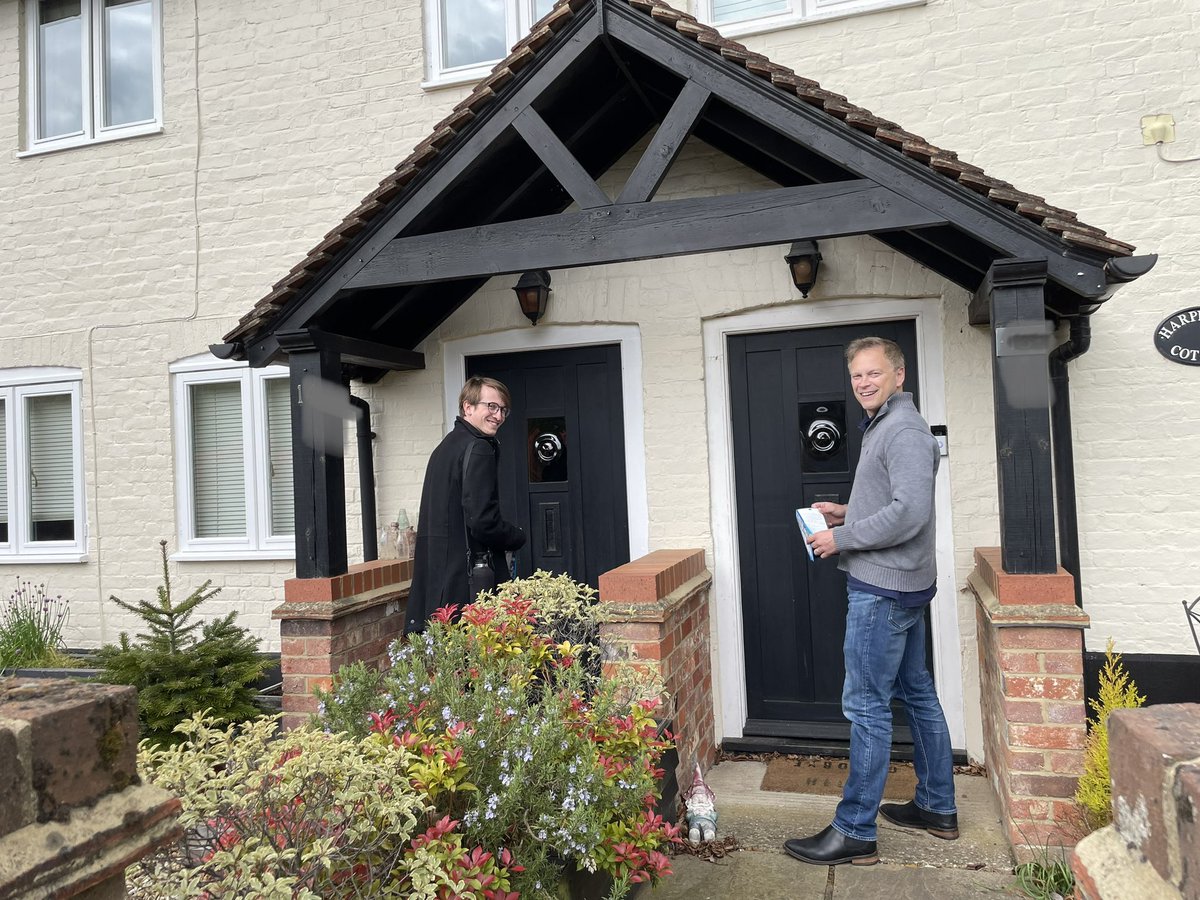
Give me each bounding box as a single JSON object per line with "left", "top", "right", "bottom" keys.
{"left": 224, "top": 0, "right": 1134, "bottom": 342}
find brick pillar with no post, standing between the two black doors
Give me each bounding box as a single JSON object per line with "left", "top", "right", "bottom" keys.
{"left": 600, "top": 550, "right": 716, "bottom": 786}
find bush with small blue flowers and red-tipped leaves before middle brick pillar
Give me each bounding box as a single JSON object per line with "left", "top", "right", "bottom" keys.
{"left": 323, "top": 596, "right": 679, "bottom": 898}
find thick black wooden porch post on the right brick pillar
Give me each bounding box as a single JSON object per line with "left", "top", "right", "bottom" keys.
{"left": 979, "top": 259, "right": 1058, "bottom": 575}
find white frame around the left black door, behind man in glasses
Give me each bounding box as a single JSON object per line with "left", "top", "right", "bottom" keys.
{"left": 442, "top": 325, "right": 650, "bottom": 559}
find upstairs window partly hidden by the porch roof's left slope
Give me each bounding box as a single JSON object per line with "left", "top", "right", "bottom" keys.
{"left": 425, "top": 0, "right": 554, "bottom": 85}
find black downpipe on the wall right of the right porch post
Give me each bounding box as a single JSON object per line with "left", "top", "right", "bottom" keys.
{"left": 1050, "top": 313, "right": 1092, "bottom": 608}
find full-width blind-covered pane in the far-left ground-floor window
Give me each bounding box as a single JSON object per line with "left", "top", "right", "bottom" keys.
{"left": 26, "top": 394, "right": 74, "bottom": 541}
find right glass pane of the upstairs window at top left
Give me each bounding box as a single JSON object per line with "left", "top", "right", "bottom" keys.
{"left": 104, "top": 0, "right": 154, "bottom": 125}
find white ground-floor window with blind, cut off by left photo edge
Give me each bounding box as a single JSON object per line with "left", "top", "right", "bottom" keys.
{"left": 0, "top": 368, "right": 85, "bottom": 563}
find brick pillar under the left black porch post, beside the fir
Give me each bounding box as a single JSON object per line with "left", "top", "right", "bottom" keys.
{"left": 271, "top": 559, "right": 413, "bottom": 728}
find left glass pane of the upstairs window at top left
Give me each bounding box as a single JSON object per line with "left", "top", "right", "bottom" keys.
{"left": 37, "top": 0, "right": 83, "bottom": 138}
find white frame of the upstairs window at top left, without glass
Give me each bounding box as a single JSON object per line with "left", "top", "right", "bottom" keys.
{"left": 17, "top": 0, "right": 162, "bottom": 157}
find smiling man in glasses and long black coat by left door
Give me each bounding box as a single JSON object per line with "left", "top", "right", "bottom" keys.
{"left": 404, "top": 376, "right": 526, "bottom": 635}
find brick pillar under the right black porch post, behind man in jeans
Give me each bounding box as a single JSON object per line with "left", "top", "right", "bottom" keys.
{"left": 967, "top": 547, "right": 1088, "bottom": 862}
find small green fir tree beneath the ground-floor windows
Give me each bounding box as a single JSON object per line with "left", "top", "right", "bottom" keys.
{"left": 97, "top": 541, "right": 268, "bottom": 744}
